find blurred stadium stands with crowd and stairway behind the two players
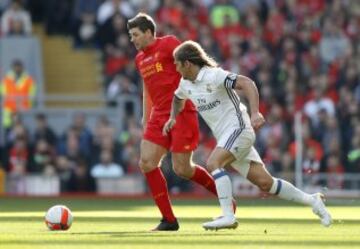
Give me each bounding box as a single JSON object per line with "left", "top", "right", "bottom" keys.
{"left": 0, "top": 0, "right": 360, "bottom": 197}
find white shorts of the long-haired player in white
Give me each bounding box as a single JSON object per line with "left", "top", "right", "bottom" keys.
{"left": 217, "top": 115, "right": 264, "bottom": 178}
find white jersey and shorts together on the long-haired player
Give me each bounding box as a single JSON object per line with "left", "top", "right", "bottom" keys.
{"left": 175, "top": 67, "right": 263, "bottom": 177}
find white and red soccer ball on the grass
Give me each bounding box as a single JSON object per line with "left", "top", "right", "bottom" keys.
{"left": 45, "top": 205, "right": 73, "bottom": 230}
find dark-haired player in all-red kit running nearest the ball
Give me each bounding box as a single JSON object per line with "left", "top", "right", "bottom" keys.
{"left": 127, "top": 13, "right": 228, "bottom": 231}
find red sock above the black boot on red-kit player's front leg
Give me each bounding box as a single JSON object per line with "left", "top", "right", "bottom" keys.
{"left": 144, "top": 167, "right": 176, "bottom": 222}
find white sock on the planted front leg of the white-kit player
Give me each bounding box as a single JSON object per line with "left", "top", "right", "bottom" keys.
{"left": 211, "top": 169, "right": 234, "bottom": 216}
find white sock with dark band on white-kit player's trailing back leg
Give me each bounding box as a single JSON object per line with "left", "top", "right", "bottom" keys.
{"left": 269, "top": 178, "right": 314, "bottom": 206}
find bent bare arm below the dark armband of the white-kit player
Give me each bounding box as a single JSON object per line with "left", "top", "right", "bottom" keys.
{"left": 235, "top": 75, "right": 265, "bottom": 130}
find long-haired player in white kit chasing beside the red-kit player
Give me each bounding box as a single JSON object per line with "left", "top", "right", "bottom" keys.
{"left": 163, "top": 41, "right": 332, "bottom": 230}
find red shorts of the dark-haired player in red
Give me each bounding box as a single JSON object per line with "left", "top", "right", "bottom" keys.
{"left": 143, "top": 111, "right": 199, "bottom": 153}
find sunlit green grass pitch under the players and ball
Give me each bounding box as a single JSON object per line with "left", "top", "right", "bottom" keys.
{"left": 0, "top": 198, "right": 360, "bottom": 249}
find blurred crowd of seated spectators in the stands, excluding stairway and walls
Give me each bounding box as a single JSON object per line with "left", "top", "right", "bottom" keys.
{"left": 0, "top": 0, "right": 360, "bottom": 194}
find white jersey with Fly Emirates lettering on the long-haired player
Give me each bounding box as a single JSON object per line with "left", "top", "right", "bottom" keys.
{"left": 175, "top": 67, "right": 252, "bottom": 141}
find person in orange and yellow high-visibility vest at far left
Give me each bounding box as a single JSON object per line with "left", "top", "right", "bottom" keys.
{"left": 0, "top": 60, "right": 36, "bottom": 127}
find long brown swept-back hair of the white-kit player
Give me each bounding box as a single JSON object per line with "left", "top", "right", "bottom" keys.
{"left": 173, "top": 41, "right": 217, "bottom": 67}
